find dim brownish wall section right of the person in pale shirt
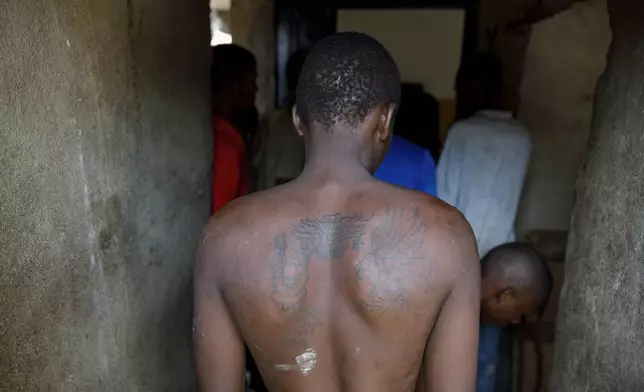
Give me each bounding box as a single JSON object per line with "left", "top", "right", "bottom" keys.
{"left": 517, "top": 0, "right": 611, "bottom": 231}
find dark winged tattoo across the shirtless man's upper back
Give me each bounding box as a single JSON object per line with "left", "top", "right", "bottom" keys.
{"left": 271, "top": 207, "right": 429, "bottom": 312}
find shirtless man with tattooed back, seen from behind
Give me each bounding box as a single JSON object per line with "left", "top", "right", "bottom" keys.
{"left": 194, "top": 33, "right": 480, "bottom": 392}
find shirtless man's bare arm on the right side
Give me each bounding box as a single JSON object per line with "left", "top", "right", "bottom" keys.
{"left": 421, "top": 217, "right": 481, "bottom": 392}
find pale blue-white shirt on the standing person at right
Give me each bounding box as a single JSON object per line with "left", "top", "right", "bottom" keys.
{"left": 437, "top": 110, "right": 531, "bottom": 255}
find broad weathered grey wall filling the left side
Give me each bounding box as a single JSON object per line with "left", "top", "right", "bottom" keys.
{"left": 0, "top": 0, "right": 211, "bottom": 392}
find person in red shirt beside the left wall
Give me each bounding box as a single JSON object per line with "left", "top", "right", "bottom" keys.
{"left": 210, "top": 44, "right": 257, "bottom": 213}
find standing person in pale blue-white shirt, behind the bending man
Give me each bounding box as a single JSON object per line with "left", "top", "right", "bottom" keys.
{"left": 436, "top": 55, "right": 531, "bottom": 392}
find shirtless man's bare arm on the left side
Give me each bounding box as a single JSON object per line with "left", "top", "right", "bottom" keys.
{"left": 194, "top": 239, "right": 246, "bottom": 392}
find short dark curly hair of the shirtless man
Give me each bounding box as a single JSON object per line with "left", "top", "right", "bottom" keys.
{"left": 296, "top": 33, "right": 401, "bottom": 133}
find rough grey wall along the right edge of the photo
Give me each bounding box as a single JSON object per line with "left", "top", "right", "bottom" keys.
{"left": 550, "top": 0, "right": 644, "bottom": 392}
